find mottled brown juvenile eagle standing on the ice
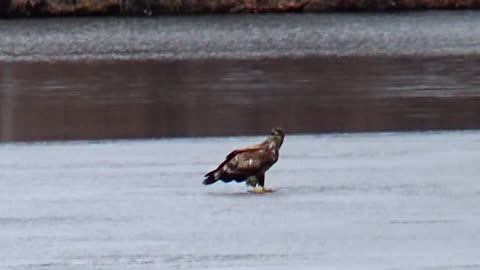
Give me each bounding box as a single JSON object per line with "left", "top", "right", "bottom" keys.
{"left": 203, "top": 128, "right": 285, "bottom": 192}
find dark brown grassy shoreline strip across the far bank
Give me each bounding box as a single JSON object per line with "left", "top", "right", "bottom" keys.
{"left": 0, "top": 0, "right": 480, "bottom": 17}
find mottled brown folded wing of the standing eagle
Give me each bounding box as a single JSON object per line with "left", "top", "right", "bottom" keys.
{"left": 203, "top": 144, "right": 271, "bottom": 185}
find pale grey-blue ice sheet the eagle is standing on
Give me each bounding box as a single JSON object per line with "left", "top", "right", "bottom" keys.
{"left": 0, "top": 131, "right": 480, "bottom": 270}
